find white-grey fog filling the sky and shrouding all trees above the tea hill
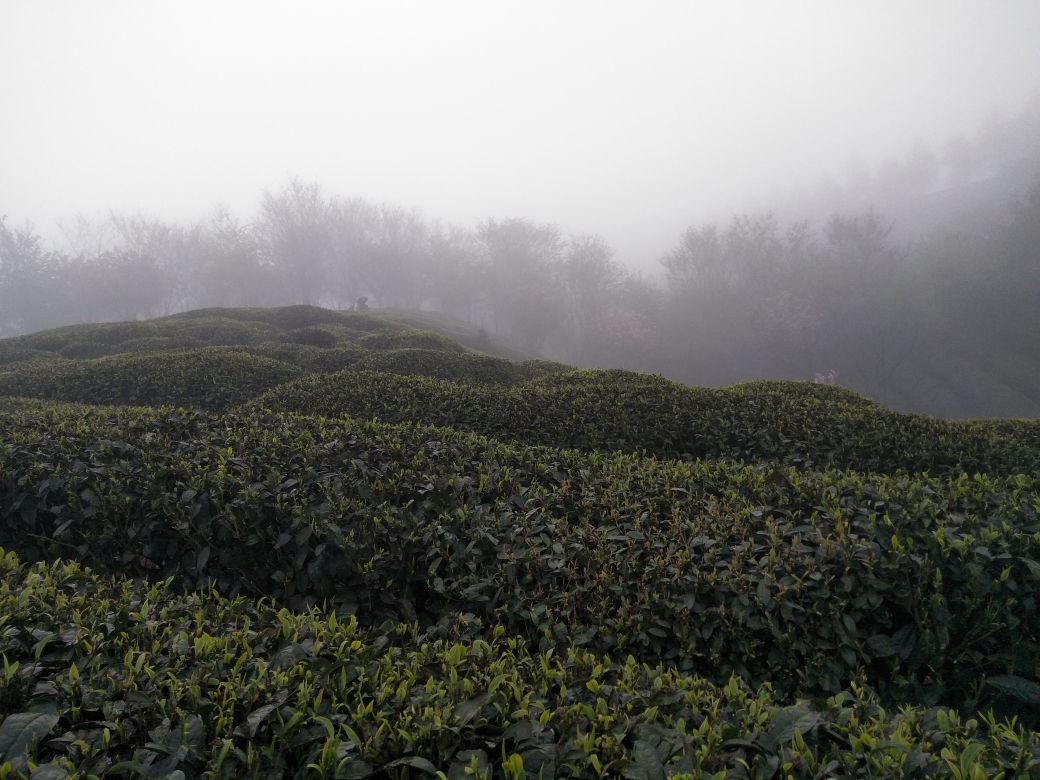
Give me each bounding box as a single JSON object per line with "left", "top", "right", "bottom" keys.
{"left": 0, "top": 2, "right": 1040, "bottom": 416}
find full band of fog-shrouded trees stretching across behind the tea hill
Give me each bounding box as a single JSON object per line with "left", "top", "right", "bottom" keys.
{"left": 0, "top": 105, "right": 1040, "bottom": 416}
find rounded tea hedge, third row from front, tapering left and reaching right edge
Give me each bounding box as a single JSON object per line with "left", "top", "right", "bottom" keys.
{"left": 251, "top": 370, "right": 1040, "bottom": 474}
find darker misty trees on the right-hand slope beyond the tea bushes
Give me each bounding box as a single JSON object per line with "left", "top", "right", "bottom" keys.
{"left": 661, "top": 192, "right": 1040, "bottom": 416}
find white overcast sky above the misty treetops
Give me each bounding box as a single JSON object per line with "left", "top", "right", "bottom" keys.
{"left": 0, "top": 0, "right": 1040, "bottom": 264}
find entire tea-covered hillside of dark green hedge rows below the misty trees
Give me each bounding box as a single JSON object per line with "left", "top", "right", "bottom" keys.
{"left": 0, "top": 307, "right": 1040, "bottom": 778}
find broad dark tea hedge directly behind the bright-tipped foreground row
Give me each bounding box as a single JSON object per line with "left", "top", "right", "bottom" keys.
{"left": 0, "top": 406, "right": 1040, "bottom": 706}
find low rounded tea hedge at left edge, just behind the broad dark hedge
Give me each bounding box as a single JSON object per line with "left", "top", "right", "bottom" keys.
{"left": 0, "top": 347, "right": 302, "bottom": 409}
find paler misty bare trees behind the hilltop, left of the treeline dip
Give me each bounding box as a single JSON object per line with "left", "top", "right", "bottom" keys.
{"left": 0, "top": 180, "right": 660, "bottom": 370}
